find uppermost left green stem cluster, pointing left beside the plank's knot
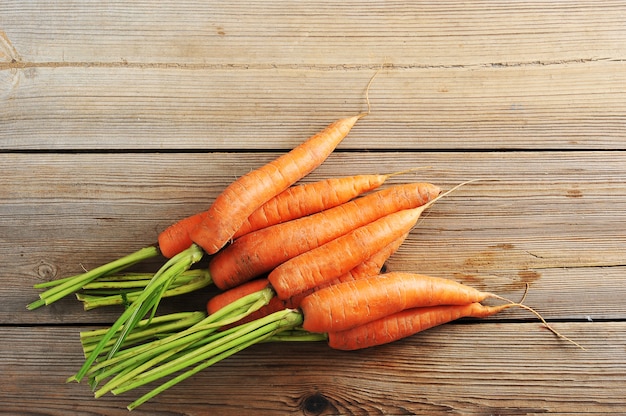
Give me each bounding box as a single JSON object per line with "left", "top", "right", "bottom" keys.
{"left": 26, "top": 246, "right": 159, "bottom": 310}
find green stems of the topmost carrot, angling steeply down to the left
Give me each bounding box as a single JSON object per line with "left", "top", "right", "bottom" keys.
{"left": 70, "top": 244, "right": 202, "bottom": 381}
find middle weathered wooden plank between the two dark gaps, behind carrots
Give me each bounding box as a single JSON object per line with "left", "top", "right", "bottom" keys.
{"left": 0, "top": 152, "right": 626, "bottom": 324}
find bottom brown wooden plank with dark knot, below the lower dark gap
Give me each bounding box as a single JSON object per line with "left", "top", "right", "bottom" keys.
{"left": 0, "top": 322, "right": 626, "bottom": 415}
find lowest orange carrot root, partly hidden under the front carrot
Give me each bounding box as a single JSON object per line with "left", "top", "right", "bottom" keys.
{"left": 328, "top": 302, "right": 511, "bottom": 351}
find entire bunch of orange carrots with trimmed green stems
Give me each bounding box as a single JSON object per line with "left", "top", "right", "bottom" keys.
{"left": 28, "top": 77, "right": 573, "bottom": 409}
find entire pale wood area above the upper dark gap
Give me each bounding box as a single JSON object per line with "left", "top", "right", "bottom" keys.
{"left": 0, "top": 1, "right": 626, "bottom": 149}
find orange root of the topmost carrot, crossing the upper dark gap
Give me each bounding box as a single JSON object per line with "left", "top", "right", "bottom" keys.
{"left": 190, "top": 115, "right": 363, "bottom": 254}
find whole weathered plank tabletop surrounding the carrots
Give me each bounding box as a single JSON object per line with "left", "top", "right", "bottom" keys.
{"left": 0, "top": 0, "right": 626, "bottom": 415}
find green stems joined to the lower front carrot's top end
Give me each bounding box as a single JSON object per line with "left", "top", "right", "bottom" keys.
{"left": 112, "top": 309, "right": 303, "bottom": 394}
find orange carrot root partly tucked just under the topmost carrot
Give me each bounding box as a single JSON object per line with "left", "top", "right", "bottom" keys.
{"left": 233, "top": 174, "right": 389, "bottom": 239}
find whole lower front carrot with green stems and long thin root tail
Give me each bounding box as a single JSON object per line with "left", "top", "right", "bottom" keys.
{"left": 88, "top": 273, "right": 577, "bottom": 409}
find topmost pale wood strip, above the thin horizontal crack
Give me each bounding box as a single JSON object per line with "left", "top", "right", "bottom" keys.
{"left": 0, "top": 0, "right": 626, "bottom": 67}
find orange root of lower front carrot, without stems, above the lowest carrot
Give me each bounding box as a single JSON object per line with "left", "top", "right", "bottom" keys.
{"left": 300, "top": 272, "right": 494, "bottom": 333}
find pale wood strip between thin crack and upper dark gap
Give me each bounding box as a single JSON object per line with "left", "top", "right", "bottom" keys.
{"left": 0, "top": 63, "right": 626, "bottom": 150}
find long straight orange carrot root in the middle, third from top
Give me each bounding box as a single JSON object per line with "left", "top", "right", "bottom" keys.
{"left": 209, "top": 183, "right": 441, "bottom": 289}
